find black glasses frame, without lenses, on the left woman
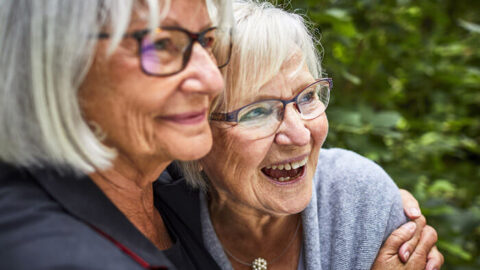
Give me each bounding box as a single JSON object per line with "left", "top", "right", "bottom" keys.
{"left": 97, "top": 26, "right": 233, "bottom": 77}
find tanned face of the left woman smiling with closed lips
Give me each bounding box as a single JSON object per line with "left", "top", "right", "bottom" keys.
{"left": 79, "top": 0, "right": 224, "bottom": 170}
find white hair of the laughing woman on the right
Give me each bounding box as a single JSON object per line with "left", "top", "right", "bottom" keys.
{"left": 177, "top": 0, "right": 322, "bottom": 189}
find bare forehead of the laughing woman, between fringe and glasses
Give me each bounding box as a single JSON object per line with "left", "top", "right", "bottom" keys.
{"left": 230, "top": 57, "right": 315, "bottom": 109}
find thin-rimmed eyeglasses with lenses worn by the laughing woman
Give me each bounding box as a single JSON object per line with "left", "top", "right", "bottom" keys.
{"left": 210, "top": 78, "right": 333, "bottom": 140}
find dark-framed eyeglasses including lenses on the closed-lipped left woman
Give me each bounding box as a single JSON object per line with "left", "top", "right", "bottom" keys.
{"left": 98, "top": 27, "right": 232, "bottom": 77}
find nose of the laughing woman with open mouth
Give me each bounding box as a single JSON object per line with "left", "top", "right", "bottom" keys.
{"left": 275, "top": 103, "right": 311, "bottom": 146}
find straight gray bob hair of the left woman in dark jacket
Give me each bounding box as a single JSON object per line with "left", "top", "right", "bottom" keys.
{"left": 0, "top": 0, "right": 232, "bottom": 173}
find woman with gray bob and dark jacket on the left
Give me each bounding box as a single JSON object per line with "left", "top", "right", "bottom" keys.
{"left": 0, "top": 0, "right": 232, "bottom": 270}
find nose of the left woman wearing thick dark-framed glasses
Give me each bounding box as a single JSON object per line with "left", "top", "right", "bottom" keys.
{"left": 182, "top": 42, "right": 224, "bottom": 96}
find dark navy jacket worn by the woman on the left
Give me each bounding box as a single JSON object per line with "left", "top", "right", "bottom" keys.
{"left": 0, "top": 163, "right": 219, "bottom": 270}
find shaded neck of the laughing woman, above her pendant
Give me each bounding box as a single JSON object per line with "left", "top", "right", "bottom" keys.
{"left": 209, "top": 189, "right": 302, "bottom": 269}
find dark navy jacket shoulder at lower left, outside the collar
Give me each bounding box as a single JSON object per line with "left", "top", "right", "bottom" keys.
{"left": 0, "top": 164, "right": 141, "bottom": 269}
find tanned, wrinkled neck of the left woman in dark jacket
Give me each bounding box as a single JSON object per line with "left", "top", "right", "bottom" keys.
{"left": 89, "top": 157, "right": 171, "bottom": 249}
